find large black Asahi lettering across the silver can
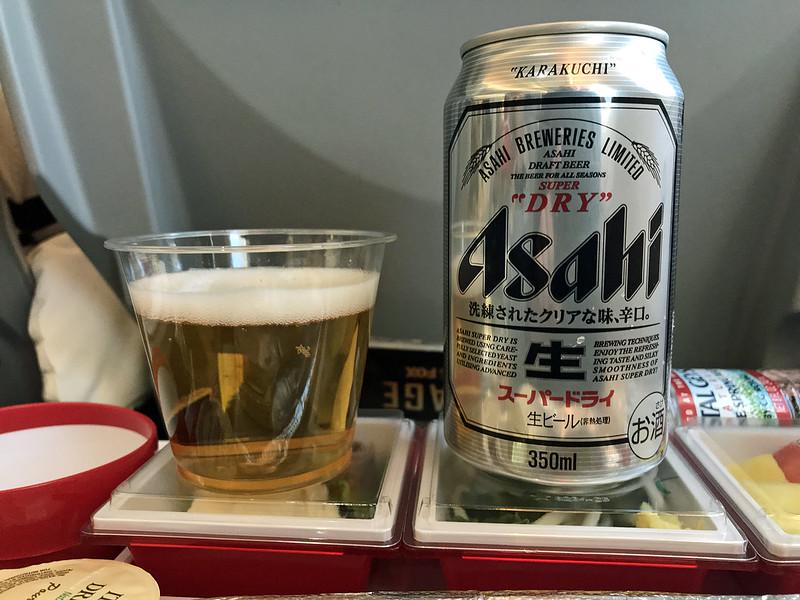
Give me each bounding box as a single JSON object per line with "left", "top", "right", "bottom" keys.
{"left": 458, "top": 204, "right": 664, "bottom": 302}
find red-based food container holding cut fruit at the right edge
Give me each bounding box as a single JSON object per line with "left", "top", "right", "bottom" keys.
{"left": 677, "top": 425, "right": 800, "bottom": 594}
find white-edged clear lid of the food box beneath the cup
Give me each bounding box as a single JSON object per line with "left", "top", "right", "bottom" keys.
{"left": 87, "top": 417, "right": 414, "bottom": 546}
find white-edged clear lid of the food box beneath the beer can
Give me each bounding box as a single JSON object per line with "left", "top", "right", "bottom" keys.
{"left": 413, "top": 423, "right": 749, "bottom": 560}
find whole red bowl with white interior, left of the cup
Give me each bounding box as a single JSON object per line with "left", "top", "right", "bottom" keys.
{"left": 0, "top": 402, "right": 156, "bottom": 569}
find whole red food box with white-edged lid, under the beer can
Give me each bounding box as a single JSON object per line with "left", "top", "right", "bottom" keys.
{"left": 405, "top": 422, "right": 756, "bottom": 592}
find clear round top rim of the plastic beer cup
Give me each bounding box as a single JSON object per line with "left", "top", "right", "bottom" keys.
{"left": 103, "top": 228, "right": 397, "bottom": 254}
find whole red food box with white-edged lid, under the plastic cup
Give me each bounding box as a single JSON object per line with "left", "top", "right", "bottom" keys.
{"left": 86, "top": 417, "right": 414, "bottom": 597}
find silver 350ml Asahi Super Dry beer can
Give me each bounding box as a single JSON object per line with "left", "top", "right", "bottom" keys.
{"left": 444, "top": 22, "right": 683, "bottom": 486}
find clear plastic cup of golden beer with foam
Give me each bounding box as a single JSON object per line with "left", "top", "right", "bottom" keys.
{"left": 106, "top": 230, "right": 396, "bottom": 492}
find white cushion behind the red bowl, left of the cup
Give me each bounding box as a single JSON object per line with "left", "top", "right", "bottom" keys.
{"left": 28, "top": 233, "right": 150, "bottom": 406}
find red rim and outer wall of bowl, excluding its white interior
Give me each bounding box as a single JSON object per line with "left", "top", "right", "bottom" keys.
{"left": 0, "top": 402, "right": 156, "bottom": 561}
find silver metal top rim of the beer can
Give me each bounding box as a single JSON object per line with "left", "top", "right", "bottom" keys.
{"left": 461, "top": 21, "right": 669, "bottom": 58}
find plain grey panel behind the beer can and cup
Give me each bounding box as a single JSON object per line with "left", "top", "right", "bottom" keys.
{"left": 0, "top": 0, "right": 800, "bottom": 366}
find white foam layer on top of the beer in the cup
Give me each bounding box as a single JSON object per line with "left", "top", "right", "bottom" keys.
{"left": 130, "top": 267, "right": 378, "bottom": 326}
